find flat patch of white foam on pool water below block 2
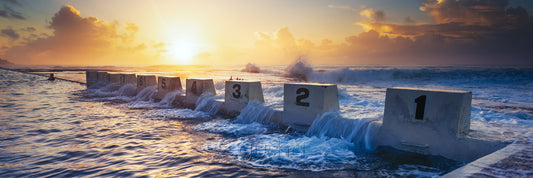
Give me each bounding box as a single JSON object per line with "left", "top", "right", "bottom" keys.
{"left": 203, "top": 133, "right": 369, "bottom": 171}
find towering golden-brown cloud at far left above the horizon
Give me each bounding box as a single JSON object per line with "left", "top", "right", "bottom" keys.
{"left": 2, "top": 5, "right": 164, "bottom": 65}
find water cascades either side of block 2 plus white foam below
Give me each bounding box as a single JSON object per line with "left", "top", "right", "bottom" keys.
{"left": 194, "top": 102, "right": 380, "bottom": 171}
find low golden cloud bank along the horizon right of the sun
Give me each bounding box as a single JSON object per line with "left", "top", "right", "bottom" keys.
{"left": 247, "top": 25, "right": 533, "bottom": 65}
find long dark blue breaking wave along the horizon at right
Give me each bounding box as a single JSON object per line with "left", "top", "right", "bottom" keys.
{"left": 285, "top": 64, "right": 533, "bottom": 87}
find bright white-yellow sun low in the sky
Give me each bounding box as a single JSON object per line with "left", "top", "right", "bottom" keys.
{"left": 166, "top": 38, "right": 199, "bottom": 64}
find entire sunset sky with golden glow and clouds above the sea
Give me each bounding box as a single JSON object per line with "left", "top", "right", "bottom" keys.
{"left": 0, "top": 0, "right": 533, "bottom": 66}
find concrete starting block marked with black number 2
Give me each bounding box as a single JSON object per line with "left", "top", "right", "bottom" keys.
{"left": 281, "top": 84, "right": 339, "bottom": 131}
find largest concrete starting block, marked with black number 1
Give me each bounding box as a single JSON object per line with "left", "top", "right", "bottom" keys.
{"left": 377, "top": 87, "right": 506, "bottom": 161}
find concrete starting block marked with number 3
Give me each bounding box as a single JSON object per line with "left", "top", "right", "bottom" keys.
{"left": 221, "top": 81, "right": 265, "bottom": 115}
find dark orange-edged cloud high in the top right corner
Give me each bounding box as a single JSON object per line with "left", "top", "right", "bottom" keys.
{"left": 357, "top": 0, "right": 531, "bottom": 39}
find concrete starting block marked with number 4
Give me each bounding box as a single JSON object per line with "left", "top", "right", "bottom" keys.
{"left": 184, "top": 79, "right": 216, "bottom": 106}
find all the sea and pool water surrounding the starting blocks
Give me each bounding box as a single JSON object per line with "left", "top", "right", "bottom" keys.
{"left": 0, "top": 63, "right": 533, "bottom": 177}
